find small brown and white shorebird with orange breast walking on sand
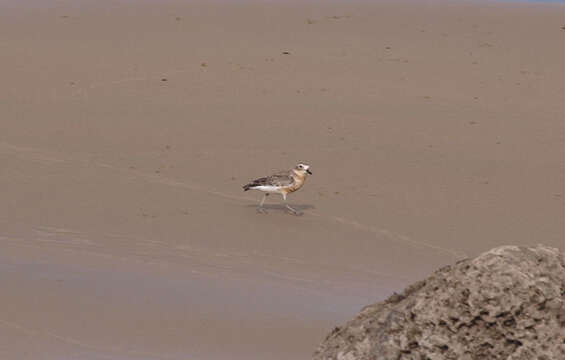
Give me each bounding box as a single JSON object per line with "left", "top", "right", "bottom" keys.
{"left": 243, "top": 163, "right": 312, "bottom": 215}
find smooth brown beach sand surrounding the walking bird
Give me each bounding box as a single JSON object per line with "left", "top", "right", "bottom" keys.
{"left": 0, "top": 0, "right": 565, "bottom": 360}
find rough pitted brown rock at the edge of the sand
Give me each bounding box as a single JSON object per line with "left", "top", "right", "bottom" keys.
{"left": 314, "top": 245, "right": 565, "bottom": 360}
